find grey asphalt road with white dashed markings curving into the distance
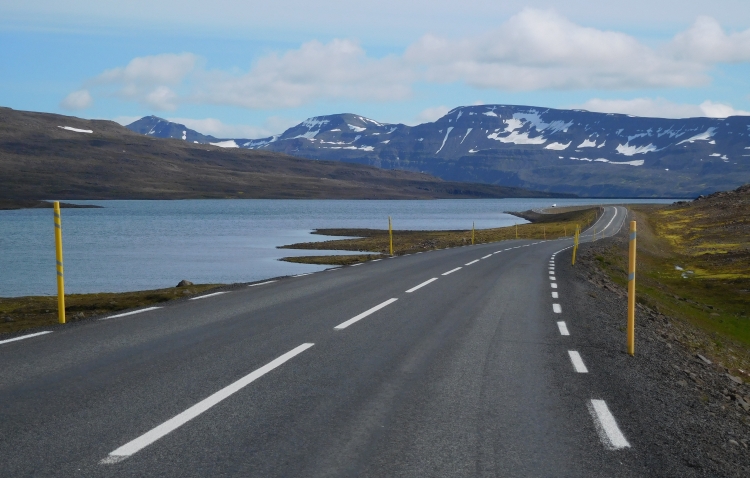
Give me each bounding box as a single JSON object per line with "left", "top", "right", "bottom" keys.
{"left": 0, "top": 207, "right": 648, "bottom": 477}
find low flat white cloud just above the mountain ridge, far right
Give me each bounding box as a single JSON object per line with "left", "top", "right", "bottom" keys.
{"left": 573, "top": 98, "right": 750, "bottom": 118}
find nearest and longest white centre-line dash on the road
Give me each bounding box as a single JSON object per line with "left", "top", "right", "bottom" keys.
{"left": 99, "top": 344, "right": 314, "bottom": 465}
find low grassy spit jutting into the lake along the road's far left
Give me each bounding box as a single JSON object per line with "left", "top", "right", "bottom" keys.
{"left": 281, "top": 207, "right": 599, "bottom": 265}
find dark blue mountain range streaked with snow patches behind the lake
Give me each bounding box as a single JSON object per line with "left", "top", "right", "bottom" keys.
{"left": 128, "top": 105, "right": 750, "bottom": 197}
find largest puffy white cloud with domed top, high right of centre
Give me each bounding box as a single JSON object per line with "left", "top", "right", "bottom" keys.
{"left": 405, "top": 9, "right": 709, "bottom": 91}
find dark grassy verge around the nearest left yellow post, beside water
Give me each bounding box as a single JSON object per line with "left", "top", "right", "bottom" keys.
{"left": 0, "top": 284, "right": 219, "bottom": 334}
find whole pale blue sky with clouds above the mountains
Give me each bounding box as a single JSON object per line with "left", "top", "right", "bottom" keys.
{"left": 0, "top": 0, "right": 750, "bottom": 138}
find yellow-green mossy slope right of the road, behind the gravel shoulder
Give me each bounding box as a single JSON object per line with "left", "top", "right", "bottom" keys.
{"left": 596, "top": 188, "right": 750, "bottom": 364}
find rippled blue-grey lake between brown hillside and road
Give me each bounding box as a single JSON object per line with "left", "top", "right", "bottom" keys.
{"left": 0, "top": 199, "right": 671, "bottom": 297}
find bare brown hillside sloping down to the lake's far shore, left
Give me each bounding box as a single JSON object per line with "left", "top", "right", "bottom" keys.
{"left": 0, "top": 108, "right": 568, "bottom": 199}
